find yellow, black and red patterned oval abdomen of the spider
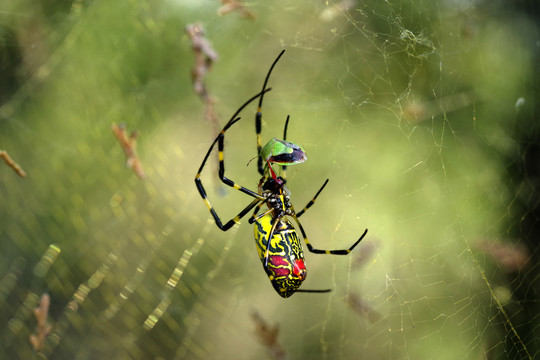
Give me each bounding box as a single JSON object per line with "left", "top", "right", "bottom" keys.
{"left": 254, "top": 214, "right": 307, "bottom": 298}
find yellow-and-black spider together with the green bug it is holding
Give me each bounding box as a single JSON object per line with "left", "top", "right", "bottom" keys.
{"left": 195, "top": 50, "right": 367, "bottom": 298}
